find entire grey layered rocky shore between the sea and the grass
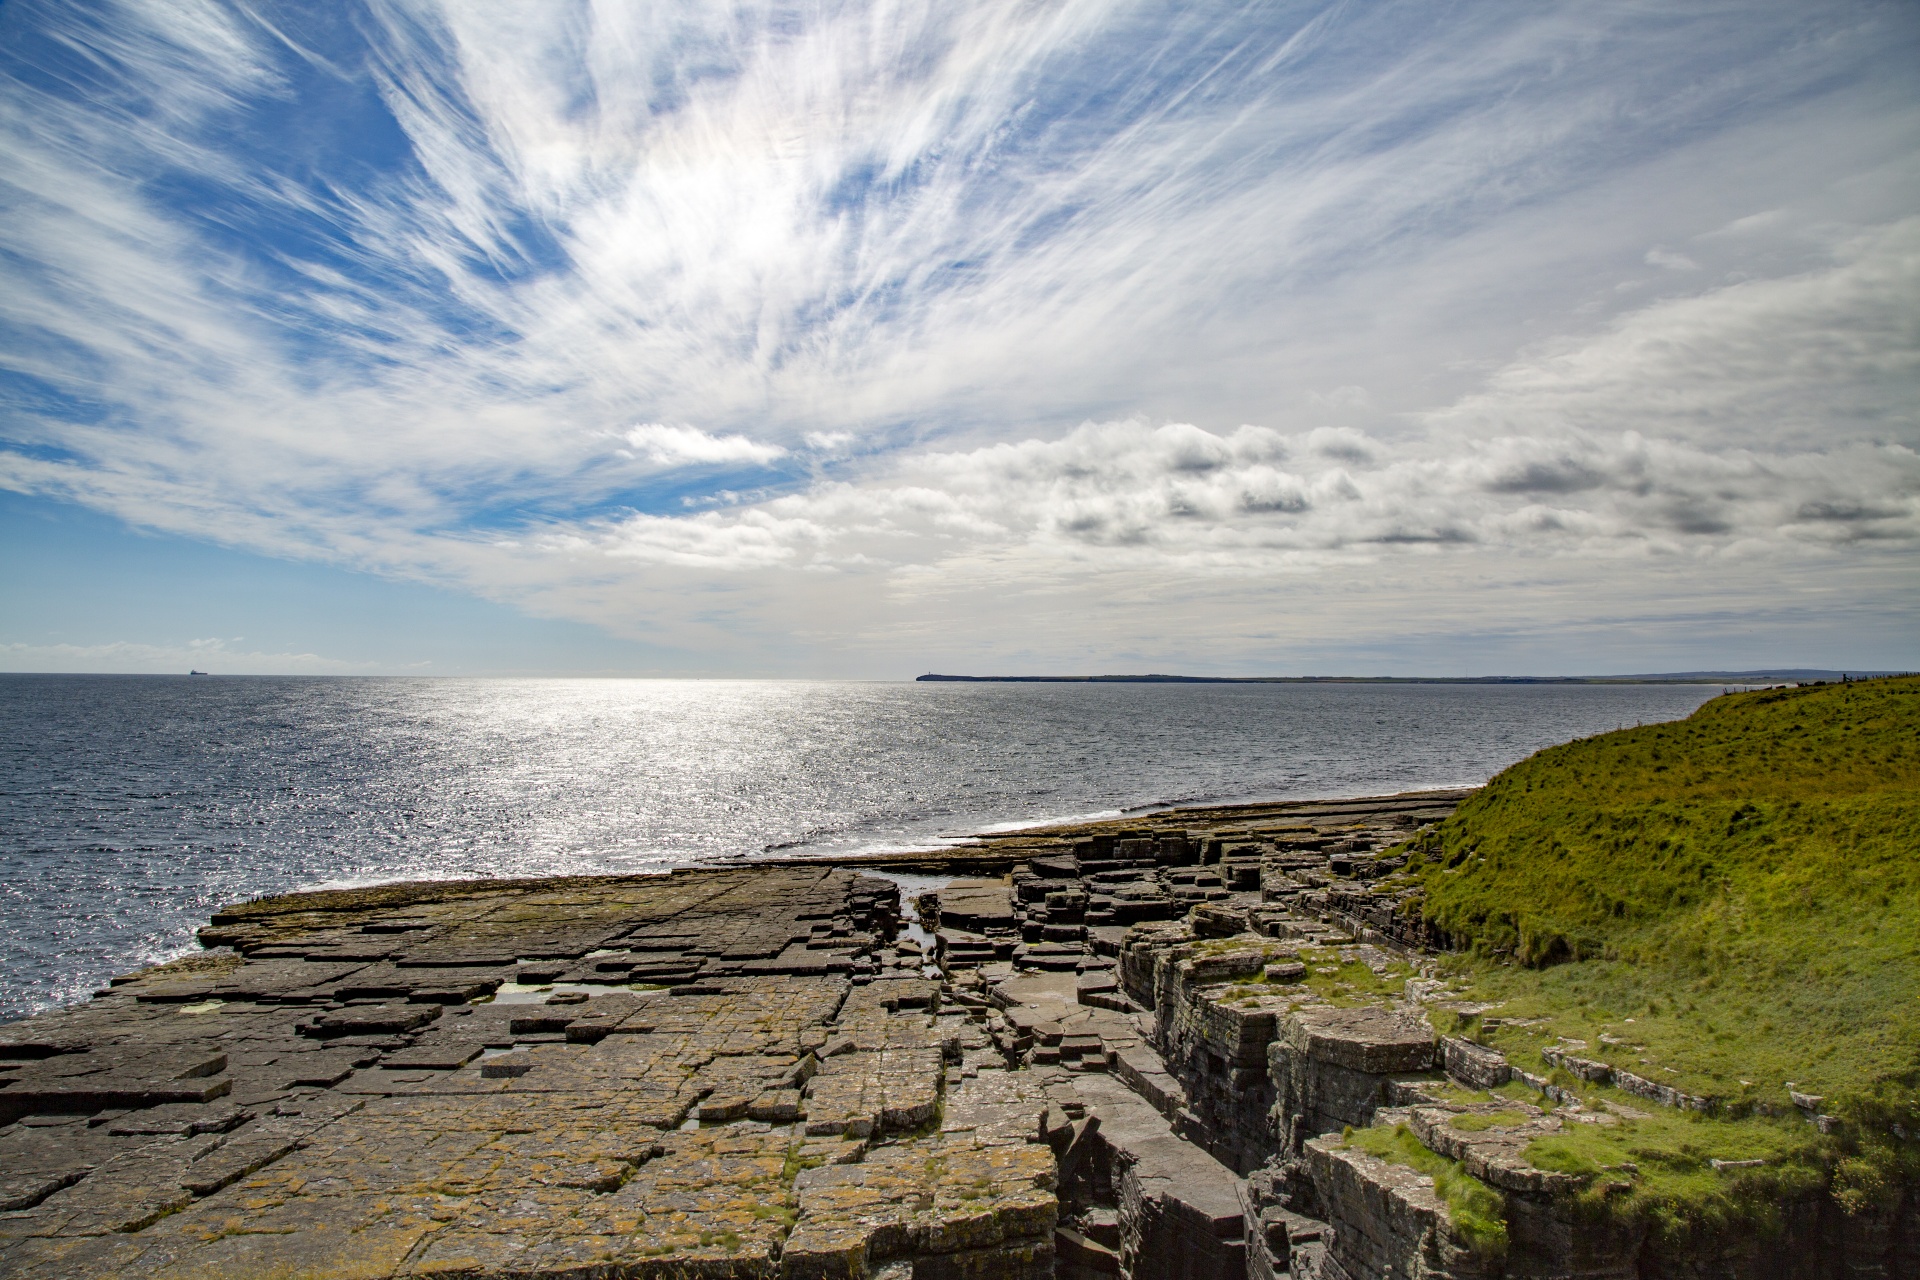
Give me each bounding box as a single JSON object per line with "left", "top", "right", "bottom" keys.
{"left": 0, "top": 793, "right": 1920, "bottom": 1280}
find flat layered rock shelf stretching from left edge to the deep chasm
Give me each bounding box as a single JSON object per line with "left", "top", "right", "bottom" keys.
{"left": 0, "top": 794, "right": 1455, "bottom": 1280}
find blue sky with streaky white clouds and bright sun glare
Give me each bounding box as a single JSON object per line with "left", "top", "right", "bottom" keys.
{"left": 0, "top": 0, "right": 1920, "bottom": 679}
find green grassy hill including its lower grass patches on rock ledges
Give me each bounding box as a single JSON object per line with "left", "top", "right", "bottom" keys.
{"left": 1388, "top": 677, "right": 1920, "bottom": 1257}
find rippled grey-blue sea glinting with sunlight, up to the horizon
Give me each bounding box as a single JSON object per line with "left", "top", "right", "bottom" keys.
{"left": 0, "top": 676, "right": 1720, "bottom": 1021}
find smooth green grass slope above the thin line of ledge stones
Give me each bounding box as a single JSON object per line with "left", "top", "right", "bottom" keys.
{"left": 1407, "top": 677, "right": 1920, "bottom": 1125}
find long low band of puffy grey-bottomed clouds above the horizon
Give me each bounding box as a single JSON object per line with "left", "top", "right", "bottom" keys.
{"left": 549, "top": 422, "right": 1920, "bottom": 574}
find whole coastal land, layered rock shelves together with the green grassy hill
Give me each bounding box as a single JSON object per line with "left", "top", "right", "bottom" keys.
{"left": 0, "top": 679, "right": 1920, "bottom": 1280}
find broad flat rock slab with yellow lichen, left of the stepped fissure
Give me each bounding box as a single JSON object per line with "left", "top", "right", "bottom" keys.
{"left": 0, "top": 867, "right": 1054, "bottom": 1280}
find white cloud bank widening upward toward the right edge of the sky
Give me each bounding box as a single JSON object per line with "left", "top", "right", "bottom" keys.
{"left": 503, "top": 219, "right": 1920, "bottom": 591}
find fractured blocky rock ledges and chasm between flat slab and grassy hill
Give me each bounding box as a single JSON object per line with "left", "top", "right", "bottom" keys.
{"left": 967, "top": 790, "right": 1751, "bottom": 1280}
